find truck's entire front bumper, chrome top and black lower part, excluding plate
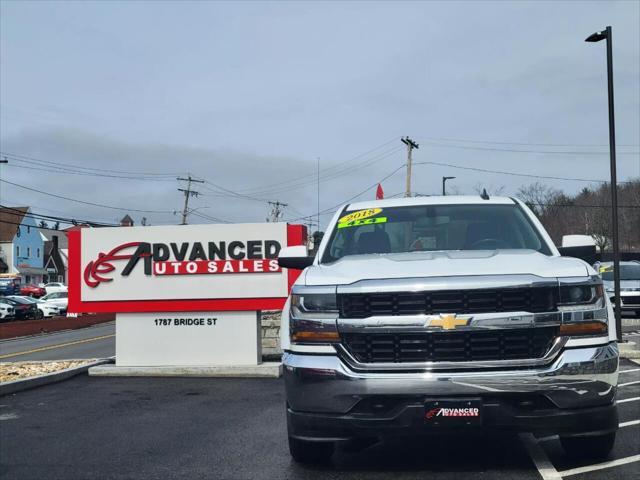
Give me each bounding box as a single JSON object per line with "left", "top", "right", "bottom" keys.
{"left": 283, "top": 342, "right": 618, "bottom": 440}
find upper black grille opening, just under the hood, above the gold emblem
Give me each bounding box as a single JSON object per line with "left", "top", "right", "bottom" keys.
{"left": 338, "top": 287, "right": 558, "bottom": 318}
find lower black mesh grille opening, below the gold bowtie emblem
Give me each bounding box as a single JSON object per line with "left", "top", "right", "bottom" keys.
{"left": 342, "top": 326, "right": 558, "bottom": 363}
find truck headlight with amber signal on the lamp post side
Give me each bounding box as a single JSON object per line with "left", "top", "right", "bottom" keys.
{"left": 558, "top": 276, "right": 608, "bottom": 336}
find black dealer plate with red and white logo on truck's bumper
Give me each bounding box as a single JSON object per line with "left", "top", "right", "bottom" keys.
{"left": 424, "top": 398, "right": 482, "bottom": 427}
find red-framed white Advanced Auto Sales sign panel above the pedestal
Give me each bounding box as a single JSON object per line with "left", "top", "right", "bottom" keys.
{"left": 69, "top": 223, "right": 306, "bottom": 312}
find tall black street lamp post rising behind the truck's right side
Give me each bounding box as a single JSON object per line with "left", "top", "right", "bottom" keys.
{"left": 585, "top": 27, "right": 622, "bottom": 342}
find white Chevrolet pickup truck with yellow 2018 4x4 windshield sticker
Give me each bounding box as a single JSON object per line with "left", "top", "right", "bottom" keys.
{"left": 279, "top": 196, "right": 618, "bottom": 462}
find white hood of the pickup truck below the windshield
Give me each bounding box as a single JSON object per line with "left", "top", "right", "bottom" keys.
{"left": 304, "top": 250, "right": 592, "bottom": 285}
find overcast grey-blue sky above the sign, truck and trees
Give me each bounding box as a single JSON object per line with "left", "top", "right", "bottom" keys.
{"left": 0, "top": 1, "right": 640, "bottom": 229}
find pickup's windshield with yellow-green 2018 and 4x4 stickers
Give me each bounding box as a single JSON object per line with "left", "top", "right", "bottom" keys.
{"left": 322, "top": 204, "right": 551, "bottom": 263}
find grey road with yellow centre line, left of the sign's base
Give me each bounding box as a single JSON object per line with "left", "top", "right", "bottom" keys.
{"left": 0, "top": 322, "right": 116, "bottom": 362}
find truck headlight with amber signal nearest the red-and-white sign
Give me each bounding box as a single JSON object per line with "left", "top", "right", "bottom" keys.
{"left": 289, "top": 286, "right": 340, "bottom": 345}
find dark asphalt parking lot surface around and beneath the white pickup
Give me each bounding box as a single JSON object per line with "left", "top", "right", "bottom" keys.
{"left": 0, "top": 360, "right": 640, "bottom": 480}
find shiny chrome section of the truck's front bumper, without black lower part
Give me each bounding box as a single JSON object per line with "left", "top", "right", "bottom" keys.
{"left": 283, "top": 342, "right": 618, "bottom": 414}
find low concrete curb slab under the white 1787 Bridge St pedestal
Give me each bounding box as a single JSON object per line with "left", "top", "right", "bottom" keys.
{"left": 89, "top": 362, "right": 282, "bottom": 378}
